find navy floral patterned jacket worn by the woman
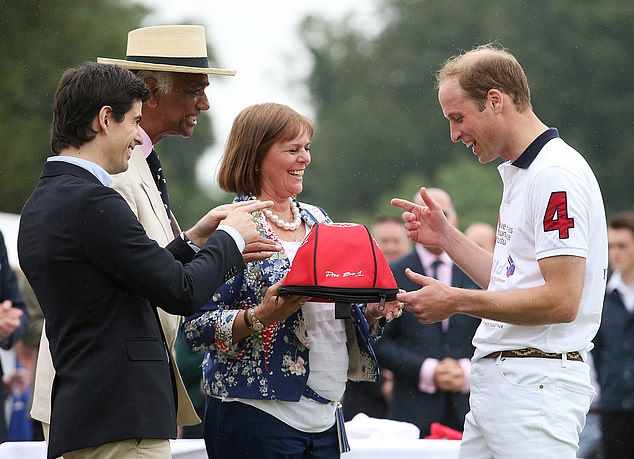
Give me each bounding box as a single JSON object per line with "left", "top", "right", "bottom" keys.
{"left": 183, "top": 195, "right": 384, "bottom": 401}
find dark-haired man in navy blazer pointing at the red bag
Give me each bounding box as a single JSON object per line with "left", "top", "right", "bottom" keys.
{"left": 18, "top": 63, "right": 270, "bottom": 458}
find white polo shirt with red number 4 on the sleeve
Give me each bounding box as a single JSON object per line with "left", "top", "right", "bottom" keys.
{"left": 473, "top": 129, "right": 608, "bottom": 360}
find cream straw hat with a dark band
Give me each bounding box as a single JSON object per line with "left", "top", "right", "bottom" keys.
{"left": 97, "top": 25, "right": 236, "bottom": 76}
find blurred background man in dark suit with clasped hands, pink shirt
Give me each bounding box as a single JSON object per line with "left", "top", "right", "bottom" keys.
{"left": 375, "top": 189, "right": 480, "bottom": 437}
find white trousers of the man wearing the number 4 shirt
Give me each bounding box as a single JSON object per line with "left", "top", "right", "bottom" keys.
{"left": 459, "top": 357, "right": 594, "bottom": 459}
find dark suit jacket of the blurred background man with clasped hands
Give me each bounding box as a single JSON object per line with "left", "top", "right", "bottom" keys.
{"left": 375, "top": 250, "right": 480, "bottom": 436}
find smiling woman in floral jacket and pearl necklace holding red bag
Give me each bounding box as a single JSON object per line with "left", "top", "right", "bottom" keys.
{"left": 184, "top": 103, "right": 400, "bottom": 459}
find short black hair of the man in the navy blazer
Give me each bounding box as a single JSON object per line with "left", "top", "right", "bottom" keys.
{"left": 51, "top": 62, "right": 150, "bottom": 154}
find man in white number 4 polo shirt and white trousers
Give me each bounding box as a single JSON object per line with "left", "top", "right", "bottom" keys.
{"left": 392, "top": 45, "right": 607, "bottom": 459}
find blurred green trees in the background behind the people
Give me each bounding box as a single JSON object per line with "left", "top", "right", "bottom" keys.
{"left": 0, "top": 0, "right": 634, "bottom": 227}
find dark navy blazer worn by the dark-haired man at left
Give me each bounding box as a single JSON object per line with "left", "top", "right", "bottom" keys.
{"left": 18, "top": 162, "right": 244, "bottom": 458}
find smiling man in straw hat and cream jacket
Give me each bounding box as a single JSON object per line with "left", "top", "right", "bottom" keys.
{"left": 31, "top": 25, "right": 275, "bottom": 456}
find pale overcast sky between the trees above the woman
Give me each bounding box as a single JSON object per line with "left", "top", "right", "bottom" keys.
{"left": 136, "top": 0, "right": 373, "bottom": 195}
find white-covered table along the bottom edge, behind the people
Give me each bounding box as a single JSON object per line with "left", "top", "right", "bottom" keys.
{"left": 0, "top": 439, "right": 460, "bottom": 459}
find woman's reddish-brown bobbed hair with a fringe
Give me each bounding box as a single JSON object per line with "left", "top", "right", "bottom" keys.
{"left": 218, "top": 103, "right": 314, "bottom": 196}
